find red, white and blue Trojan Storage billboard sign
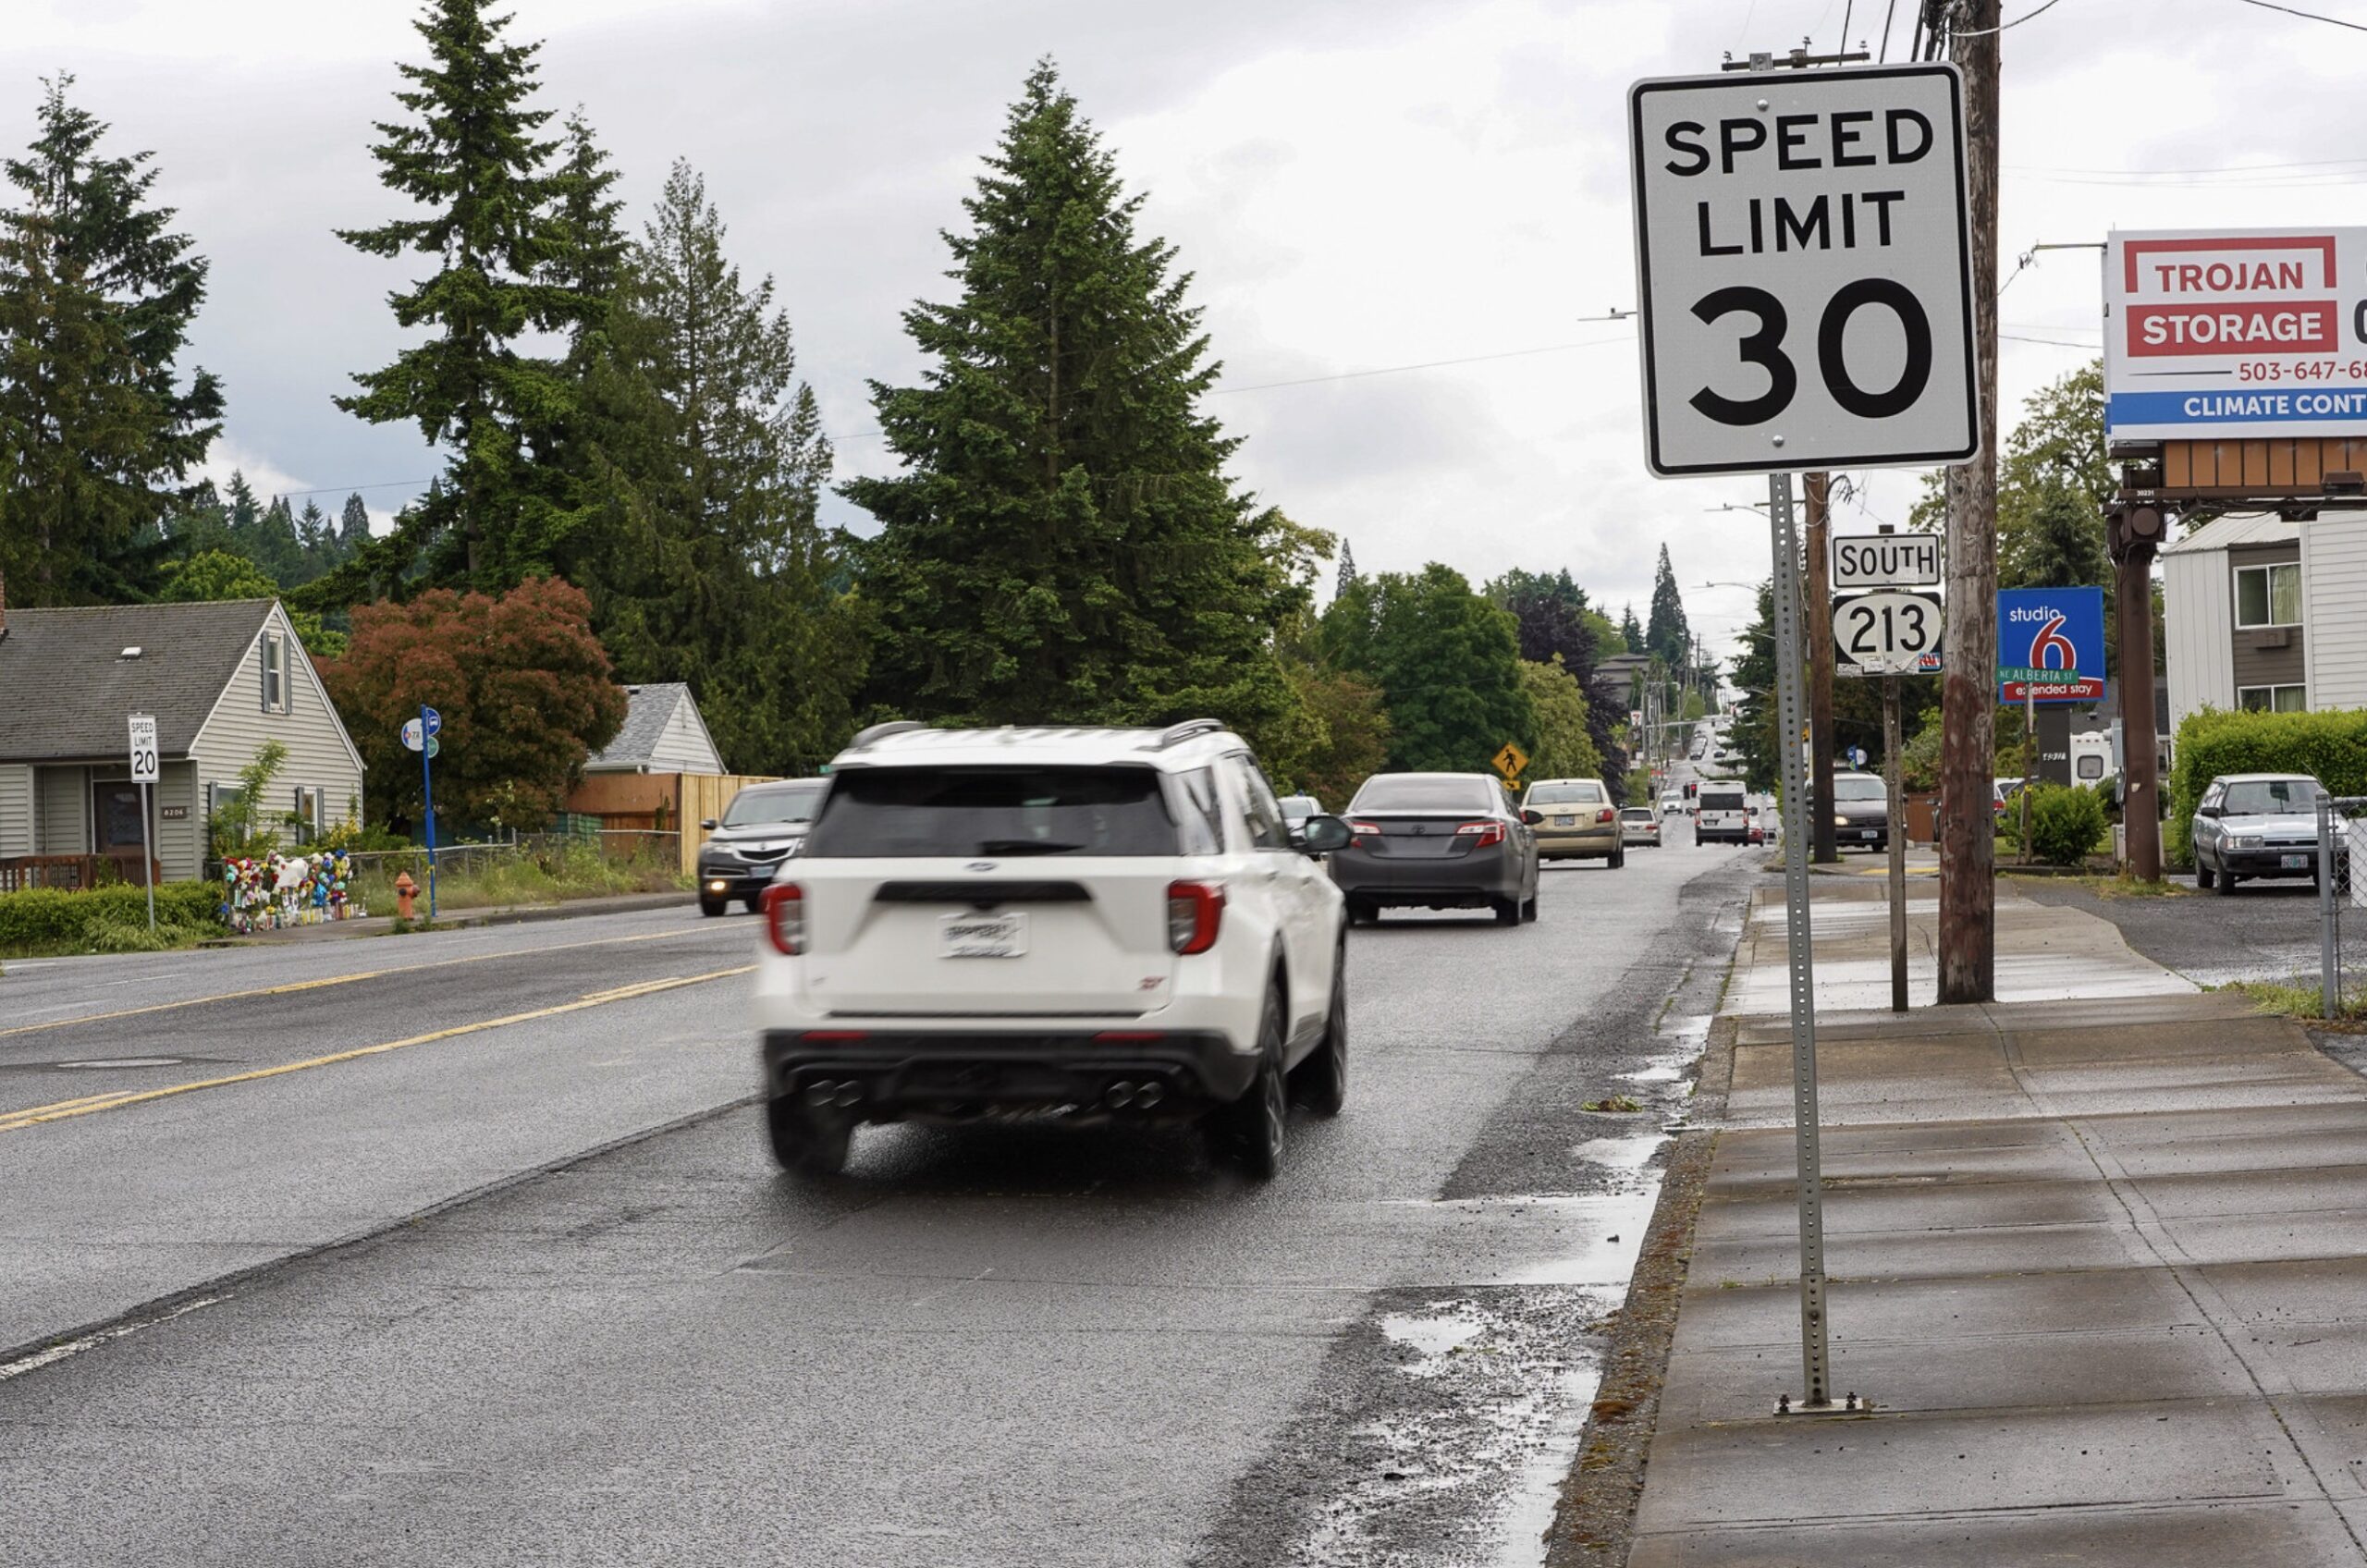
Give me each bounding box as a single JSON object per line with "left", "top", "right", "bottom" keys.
{"left": 2104, "top": 230, "right": 2367, "bottom": 441}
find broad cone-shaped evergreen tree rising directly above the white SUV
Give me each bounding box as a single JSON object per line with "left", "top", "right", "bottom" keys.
{"left": 842, "top": 62, "right": 1318, "bottom": 751}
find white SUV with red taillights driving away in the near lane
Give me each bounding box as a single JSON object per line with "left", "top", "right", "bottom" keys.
{"left": 755, "top": 720, "right": 1349, "bottom": 1177}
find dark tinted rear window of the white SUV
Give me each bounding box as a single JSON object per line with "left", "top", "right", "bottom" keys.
{"left": 803, "top": 767, "right": 1176, "bottom": 860}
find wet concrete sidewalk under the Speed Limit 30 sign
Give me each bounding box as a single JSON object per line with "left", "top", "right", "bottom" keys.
{"left": 1626, "top": 884, "right": 2367, "bottom": 1568}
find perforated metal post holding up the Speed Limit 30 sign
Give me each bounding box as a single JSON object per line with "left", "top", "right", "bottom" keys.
{"left": 1768, "top": 473, "right": 1832, "bottom": 1409}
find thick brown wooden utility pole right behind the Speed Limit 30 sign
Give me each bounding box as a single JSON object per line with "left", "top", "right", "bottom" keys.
{"left": 1934, "top": 0, "right": 2000, "bottom": 1002}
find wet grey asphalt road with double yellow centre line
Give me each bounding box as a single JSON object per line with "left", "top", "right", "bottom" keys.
{"left": 0, "top": 819, "right": 1763, "bottom": 1568}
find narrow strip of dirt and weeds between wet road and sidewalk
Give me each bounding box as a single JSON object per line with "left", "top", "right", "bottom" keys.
{"left": 1546, "top": 1016, "right": 1735, "bottom": 1568}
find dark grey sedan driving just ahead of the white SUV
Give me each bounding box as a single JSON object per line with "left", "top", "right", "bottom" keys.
{"left": 1331, "top": 772, "right": 1536, "bottom": 926}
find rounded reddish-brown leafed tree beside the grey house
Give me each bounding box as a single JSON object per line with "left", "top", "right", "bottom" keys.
{"left": 322, "top": 578, "right": 625, "bottom": 829}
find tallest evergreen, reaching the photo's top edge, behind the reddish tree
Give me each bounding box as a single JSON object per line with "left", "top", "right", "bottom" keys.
{"left": 331, "top": 0, "right": 589, "bottom": 590}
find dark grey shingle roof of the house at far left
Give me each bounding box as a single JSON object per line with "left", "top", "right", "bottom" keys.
{"left": 0, "top": 599, "right": 272, "bottom": 763}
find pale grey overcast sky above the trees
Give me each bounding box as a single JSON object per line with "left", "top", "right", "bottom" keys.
{"left": 0, "top": 0, "right": 2367, "bottom": 658}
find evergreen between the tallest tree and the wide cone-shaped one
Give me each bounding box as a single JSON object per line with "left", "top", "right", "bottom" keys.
{"left": 561, "top": 164, "right": 866, "bottom": 772}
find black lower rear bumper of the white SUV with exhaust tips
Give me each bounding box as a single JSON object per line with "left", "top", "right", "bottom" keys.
{"left": 760, "top": 1028, "right": 1257, "bottom": 1122}
